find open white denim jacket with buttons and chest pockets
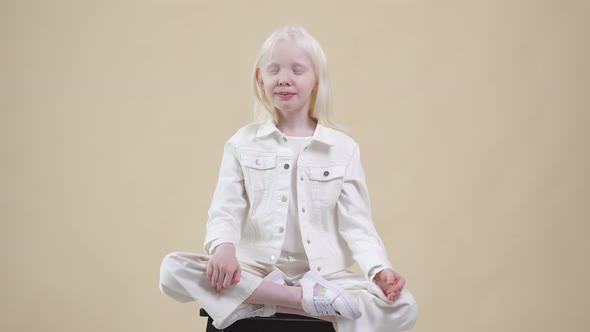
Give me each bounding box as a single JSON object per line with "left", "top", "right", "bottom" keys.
{"left": 205, "top": 120, "right": 391, "bottom": 279}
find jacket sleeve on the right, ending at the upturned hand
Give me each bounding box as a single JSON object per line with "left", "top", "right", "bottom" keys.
{"left": 337, "top": 145, "right": 391, "bottom": 278}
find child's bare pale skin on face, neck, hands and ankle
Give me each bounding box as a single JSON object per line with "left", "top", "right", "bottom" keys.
{"left": 206, "top": 40, "right": 406, "bottom": 321}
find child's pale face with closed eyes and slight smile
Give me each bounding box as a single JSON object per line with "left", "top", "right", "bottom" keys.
{"left": 258, "top": 40, "right": 317, "bottom": 115}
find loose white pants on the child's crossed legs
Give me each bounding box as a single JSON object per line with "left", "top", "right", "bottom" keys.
{"left": 160, "top": 252, "right": 417, "bottom": 332}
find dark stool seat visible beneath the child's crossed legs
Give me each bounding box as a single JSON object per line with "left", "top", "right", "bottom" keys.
{"left": 199, "top": 308, "right": 334, "bottom": 332}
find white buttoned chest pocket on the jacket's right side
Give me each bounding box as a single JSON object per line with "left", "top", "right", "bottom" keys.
{"left": 309, "top": 165, "right": 346, "bottom": 207}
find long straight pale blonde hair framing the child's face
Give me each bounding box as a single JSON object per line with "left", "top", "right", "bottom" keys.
{"left": 252, "top": 26, "right": 342, "bottom": 130}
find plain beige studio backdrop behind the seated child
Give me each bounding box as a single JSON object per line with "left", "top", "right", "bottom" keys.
{"left": 0, "top": 0, "right": 590, "bottom": 332}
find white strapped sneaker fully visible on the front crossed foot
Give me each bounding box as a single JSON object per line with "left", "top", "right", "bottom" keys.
{"left": 299, "top": 271, "right": 362, "bottom": 319}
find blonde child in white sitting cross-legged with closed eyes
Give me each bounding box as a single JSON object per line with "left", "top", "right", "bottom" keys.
{"left": 160, "top": 27, "right": 417, "bottom": 332}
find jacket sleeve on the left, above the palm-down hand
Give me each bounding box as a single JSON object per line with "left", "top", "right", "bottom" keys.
{"left": 205, "top": 139, "right": 248, "bottom": 254}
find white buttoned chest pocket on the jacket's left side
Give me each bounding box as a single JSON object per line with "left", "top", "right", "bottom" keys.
{"left": 240, "top": 154, "right": 277, "bottom": 191}
